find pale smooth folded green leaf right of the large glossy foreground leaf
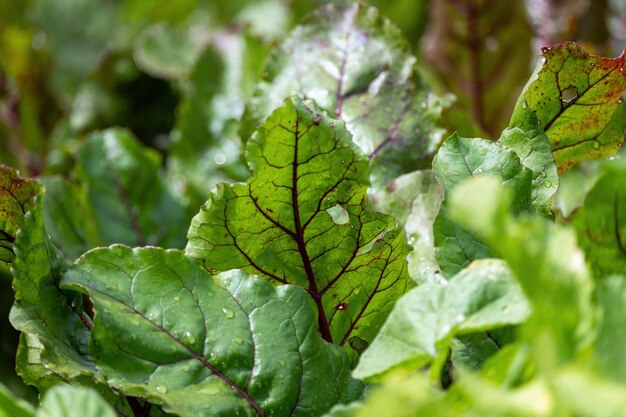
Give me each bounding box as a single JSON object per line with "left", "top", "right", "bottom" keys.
{"left": 354, "top": 260, "right": 528, "bottom": 380}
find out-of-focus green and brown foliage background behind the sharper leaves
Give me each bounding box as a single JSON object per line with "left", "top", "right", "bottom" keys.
{"left": 0, "top": 0, "right": 626, "bottom": 400}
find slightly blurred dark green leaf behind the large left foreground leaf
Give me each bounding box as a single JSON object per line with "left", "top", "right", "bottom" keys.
{"left": 77, "top": 129, "right": 188, "bottom": 248}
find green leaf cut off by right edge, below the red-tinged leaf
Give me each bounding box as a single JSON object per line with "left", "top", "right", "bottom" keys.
{"left": 574, "top": 158, "right": 626, "bottom": 278}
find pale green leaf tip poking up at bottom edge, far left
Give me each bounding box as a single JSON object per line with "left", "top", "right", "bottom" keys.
{"left": 37, "top": 385, "right": 117, "bottom": 417}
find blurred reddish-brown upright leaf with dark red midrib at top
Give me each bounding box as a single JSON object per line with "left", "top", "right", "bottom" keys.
{"left": 422, "top": 0, "right": 532, "bottom": 138}
